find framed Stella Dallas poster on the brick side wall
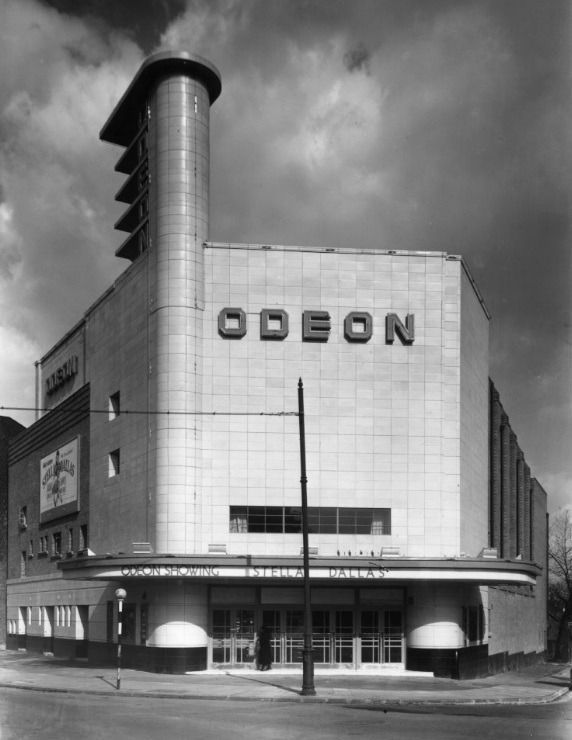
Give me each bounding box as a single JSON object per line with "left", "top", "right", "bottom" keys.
{"left": 40, "top": 437, "right": 79, "bottom": 522}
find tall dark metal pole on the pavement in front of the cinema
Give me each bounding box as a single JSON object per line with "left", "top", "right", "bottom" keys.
{"left": 298, "top": 378, "right": 316, "bottom": 696}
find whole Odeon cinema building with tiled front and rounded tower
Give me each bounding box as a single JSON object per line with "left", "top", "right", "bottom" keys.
{"left": 7, "top": 53, "right": 546, "bottom": 677}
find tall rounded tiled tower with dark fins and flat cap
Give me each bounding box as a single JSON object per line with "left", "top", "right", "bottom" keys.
{"left": 101, "top": 51, "right": 221, "bottom": 664}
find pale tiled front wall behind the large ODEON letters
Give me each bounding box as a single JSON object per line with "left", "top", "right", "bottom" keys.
{"left": 203, "top": 244, "right": 488, "bottom": 557}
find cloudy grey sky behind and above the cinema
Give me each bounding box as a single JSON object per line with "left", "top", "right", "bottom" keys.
{"left": 0, "top": 0, "right": 572, "bottom": 511}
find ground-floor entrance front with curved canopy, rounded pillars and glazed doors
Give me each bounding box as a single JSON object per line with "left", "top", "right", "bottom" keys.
{"left": 60, "top": 555, "right": 539, "bottom": 674}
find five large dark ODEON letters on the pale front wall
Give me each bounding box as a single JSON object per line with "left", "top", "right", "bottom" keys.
{"left": 218, "top": 307, "right": 415, "bottom": 344}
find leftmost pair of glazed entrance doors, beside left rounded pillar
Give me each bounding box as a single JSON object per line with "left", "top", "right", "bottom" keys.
{"left": 212, "top": 609, "right": 254, "bottom": 665}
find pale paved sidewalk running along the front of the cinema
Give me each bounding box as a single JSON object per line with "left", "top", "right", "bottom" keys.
{"left": 0, "top": 651, "right": 570, "bottom": 705}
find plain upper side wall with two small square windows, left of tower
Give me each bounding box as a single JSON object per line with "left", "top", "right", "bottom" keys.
{"left": 86, "top": 253, "right": 153, "bottom": 553}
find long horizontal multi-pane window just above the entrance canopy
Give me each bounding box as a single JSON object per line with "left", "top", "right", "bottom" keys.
{"left": 230, "top": 506, "right": 391, "bottom": 536}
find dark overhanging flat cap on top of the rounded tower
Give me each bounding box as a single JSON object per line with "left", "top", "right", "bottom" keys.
{"left": 99, "top": 51, "right": 222, "bottom": 146}
